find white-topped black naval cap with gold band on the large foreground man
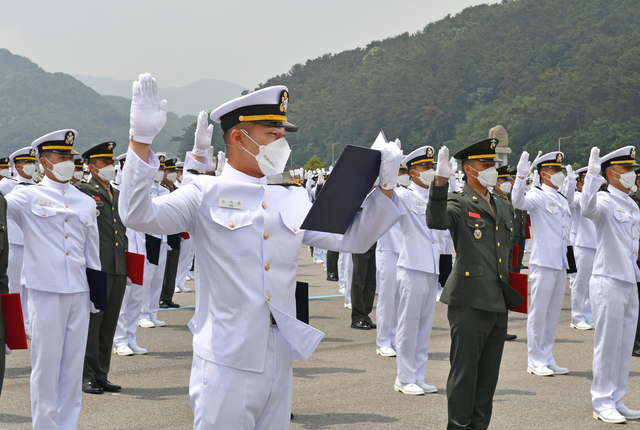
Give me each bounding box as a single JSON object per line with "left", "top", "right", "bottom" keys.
{"left": 210, "top": 85, "right": 298, "bottom": 133}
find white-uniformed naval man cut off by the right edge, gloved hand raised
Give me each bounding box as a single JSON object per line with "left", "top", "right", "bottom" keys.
{"left": 581, "top": 146, "right": 640, "bottom": 423}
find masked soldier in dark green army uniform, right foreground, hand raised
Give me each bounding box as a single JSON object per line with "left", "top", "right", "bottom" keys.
{"left": 427, "top": 139, "right": 523, "bottom": 430}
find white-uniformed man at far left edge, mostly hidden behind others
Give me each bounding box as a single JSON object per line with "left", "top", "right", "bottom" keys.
{"left": 0, "top": 146, "right": 38, "bottom": 339}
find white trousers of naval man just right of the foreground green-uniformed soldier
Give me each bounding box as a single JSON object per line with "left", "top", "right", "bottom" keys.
{"left": 527, "top": 264, "right": 567, "bottom": 368}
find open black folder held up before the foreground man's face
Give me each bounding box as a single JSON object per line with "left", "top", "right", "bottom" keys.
{"left": 300, "top": 145, "right": 381, "bottom": 234}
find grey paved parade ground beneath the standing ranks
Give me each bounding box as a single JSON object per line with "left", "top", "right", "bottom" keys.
{"left": 0, "top": 247, "right": 640, "bottom": 430}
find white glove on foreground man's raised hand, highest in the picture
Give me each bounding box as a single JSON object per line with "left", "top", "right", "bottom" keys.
{"left": 129, "top": 73, "right": 167, "bottom": 145}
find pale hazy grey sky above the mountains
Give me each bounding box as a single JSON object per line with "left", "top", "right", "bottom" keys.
{"left": 0, "top": 0, "right": 497, "bottom": 89}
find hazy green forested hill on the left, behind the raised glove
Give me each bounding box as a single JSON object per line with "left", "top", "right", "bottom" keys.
{"left": 0, "top": 49, "right": 195, "bottom": 157}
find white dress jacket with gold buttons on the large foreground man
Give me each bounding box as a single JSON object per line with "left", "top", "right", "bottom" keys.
{"left": 120, "top": 150, "right": 403, "bottom": 372}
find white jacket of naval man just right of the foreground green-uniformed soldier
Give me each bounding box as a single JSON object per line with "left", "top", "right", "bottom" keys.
{"left": 511, "top": 177, "right": 574, "bottom": 270}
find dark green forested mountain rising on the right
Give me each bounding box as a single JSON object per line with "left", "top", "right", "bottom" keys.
{"left": 241, "top": 0, "right": 640, "bottom": 165}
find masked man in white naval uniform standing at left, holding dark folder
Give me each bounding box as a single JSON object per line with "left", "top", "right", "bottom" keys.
{"left": 6, "top": 129, "right": 101, "bottom": 430}
